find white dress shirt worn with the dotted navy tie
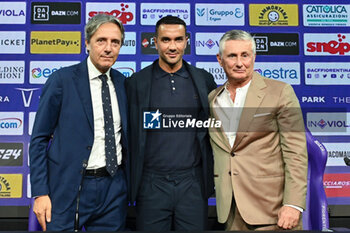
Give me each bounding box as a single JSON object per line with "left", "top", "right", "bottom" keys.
{"left": 87, "top": 57, "right": 122, "bottom": 169}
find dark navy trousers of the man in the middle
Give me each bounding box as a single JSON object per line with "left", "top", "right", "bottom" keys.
{"left": 136, "top": 168, "right": 208, "bottom": 232}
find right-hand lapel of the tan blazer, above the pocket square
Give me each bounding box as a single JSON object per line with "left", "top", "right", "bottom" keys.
{"left": 232, "top": 72, "right": 266, "bottom": 150}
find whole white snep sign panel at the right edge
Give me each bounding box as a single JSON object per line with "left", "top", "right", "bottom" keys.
{"left": 304, "top": 33, "right": 350, "bottom": 56}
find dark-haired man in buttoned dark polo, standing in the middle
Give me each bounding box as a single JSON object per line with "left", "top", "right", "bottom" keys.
{"left": 126, "top": 16, "right": 216, "bottom": 232}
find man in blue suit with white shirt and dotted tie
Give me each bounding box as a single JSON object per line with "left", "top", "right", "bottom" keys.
{"left": 29, "top": 14, "right": 128, "bottom": 231}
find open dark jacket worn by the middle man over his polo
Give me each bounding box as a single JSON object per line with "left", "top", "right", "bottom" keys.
{"left": 125, "top": 60, "right": 217, "bottom": 202}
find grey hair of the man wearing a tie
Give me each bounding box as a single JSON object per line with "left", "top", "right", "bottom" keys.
{"left": 85, "top": 14, "right": 125, "bottom": 45}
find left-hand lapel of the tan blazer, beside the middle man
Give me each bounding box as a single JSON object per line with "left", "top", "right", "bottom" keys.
{"left": 209, "top": 83, "right": 231, "bottom": 153}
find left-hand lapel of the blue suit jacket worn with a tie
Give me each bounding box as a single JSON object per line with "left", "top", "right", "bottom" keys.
{"left": 73, "top": 59, "right": 94, "bottom": 131}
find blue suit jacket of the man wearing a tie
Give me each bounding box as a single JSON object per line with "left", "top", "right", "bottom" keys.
{"left": 29, "top": 59, "right": 128, "bottom": 213}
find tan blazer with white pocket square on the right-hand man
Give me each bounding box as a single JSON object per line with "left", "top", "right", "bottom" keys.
{"left": 209, "top": 72, "right": 308, "bottom": 225}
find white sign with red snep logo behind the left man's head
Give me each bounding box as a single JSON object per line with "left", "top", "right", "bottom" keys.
{"left": 86, "top": 2, "right": 136, "bottom": 25}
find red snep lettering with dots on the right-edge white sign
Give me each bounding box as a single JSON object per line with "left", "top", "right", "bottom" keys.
{"left": 305, "top": 34, "right": 350, "bottom": 55}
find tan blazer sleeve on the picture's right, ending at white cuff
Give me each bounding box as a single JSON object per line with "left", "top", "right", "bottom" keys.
{"left": 277, "top": 85, "right": 308, "bottom": 209}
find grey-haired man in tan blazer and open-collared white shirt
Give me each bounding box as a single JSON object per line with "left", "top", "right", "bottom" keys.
{"left": 209, "top": 30, "right": 308, "bottom": 230}
